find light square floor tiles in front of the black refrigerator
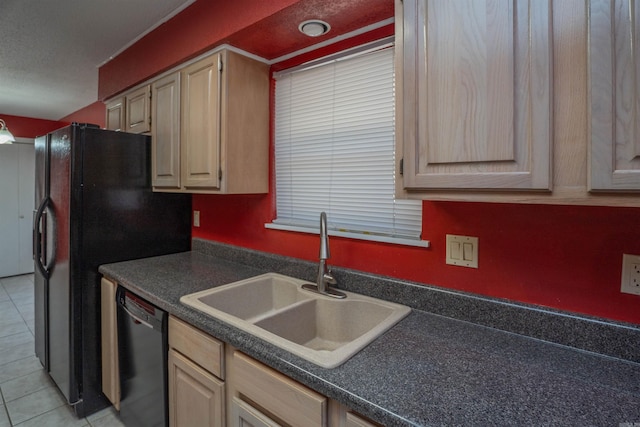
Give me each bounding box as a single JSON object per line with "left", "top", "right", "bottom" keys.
{"left": 0, "top": 274, "right": 123, "bottom": 427}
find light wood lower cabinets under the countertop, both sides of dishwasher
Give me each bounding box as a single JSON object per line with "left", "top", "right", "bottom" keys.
{"left": 101, "top": 290, "right": 380, "bottom": 427}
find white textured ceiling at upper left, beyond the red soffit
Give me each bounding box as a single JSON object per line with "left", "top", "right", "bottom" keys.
{"left": 0, "top": 0, "right": 194, "bottom": 120}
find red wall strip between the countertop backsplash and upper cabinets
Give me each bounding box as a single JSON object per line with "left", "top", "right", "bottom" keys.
{"left": 193, "top": 195, "right": 640, "bottom": 324}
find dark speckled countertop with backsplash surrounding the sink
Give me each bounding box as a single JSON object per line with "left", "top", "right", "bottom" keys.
{"left": 100, "top": 241, "right": 640, "bottom": 426}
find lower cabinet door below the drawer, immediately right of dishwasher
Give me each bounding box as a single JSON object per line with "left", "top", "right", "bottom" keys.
{"left": 169, "top": 350, "right": 224, "bottom": 427}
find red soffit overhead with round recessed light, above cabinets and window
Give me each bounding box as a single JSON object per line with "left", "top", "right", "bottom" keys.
{"left": 98, "top": 0, "right": 394, "bottom": 100}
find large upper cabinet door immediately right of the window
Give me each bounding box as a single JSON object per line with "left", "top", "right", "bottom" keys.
{"left": 396, "top": 0, "right": 553, "bottom": 190}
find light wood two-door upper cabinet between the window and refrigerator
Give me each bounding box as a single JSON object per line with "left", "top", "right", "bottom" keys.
{"left": 152, "top": 50, "right": 269, "bottom": 194}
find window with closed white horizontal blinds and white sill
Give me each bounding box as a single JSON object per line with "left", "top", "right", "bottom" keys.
{"left": 267, "top": 41, "right": 428, "bottom": 246}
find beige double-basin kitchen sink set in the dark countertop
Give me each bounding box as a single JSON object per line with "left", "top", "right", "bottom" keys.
{"left": 180, "top": 273, "right": 411, "bottom": 368}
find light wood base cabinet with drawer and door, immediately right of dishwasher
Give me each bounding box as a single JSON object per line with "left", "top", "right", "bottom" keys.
{"left": 168, "top": 316, "right": 225, "bottom": 427}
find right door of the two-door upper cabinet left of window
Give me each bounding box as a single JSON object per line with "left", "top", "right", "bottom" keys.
{"left": 181, "top": 54, "right": 221, "bottom": 189}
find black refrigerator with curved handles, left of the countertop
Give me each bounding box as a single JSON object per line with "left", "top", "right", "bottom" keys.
{"left": 33, "top": 123, "right": 191, "bottom": 417}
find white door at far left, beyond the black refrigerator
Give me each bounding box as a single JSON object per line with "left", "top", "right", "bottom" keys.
{"left": 0, "top": 141, "right": 35, "bottom": 277}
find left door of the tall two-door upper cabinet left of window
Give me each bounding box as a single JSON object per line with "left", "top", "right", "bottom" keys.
{"left": 151, "top": 73, "right": 180, "bottom": 188}
